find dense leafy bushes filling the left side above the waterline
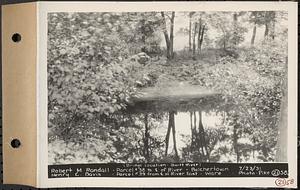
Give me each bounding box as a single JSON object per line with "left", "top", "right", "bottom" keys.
{"left": 48, "top": 13, "right": 138, "bottom": 119}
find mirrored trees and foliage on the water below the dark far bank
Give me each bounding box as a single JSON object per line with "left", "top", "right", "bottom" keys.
{"left": 49, "top": 109, "right": 276, "bottom": 164}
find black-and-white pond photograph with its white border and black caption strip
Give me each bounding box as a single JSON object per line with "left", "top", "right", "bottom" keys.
{"left": 1, "top": 2, "right": 297, "bottom": 188}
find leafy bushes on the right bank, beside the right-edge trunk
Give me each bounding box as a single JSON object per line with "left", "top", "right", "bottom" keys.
{"left": 191, "top": 40, "right": 287, "bottom": 159}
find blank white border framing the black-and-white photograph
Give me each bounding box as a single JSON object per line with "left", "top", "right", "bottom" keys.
{"left": 37, "top": 1, "right": 298, "bottom": 188}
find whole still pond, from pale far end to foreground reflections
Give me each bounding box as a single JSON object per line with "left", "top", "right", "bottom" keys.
{"left": 49, "top": 85, "right": 277, "bottom": 164}
